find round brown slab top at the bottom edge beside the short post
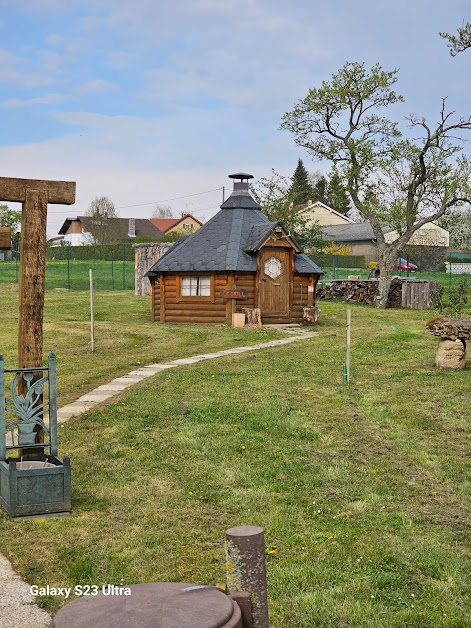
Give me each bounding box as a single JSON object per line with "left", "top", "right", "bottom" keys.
{"left": 50, "top": 582, "right": 242, "bottom": 628}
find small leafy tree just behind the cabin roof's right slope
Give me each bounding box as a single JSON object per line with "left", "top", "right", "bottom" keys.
{"left": 250, "top": 169, "right": 321, "bottom": 250}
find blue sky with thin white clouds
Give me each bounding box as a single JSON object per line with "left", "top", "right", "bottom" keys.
{"left": 0, "top": 0, "right": 471, "bottom": 237}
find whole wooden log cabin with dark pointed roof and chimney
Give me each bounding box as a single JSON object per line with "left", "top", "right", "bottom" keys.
{"left": 146, "top": 173, "right": 322, "bottom": 324}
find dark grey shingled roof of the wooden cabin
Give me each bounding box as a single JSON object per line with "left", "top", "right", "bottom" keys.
{"left": 147, "top": 177, "right": 322, "bottom": 277}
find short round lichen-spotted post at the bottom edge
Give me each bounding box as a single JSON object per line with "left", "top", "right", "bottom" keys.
{"left": 226, "top": 526, "right": 269, "bottom": 628}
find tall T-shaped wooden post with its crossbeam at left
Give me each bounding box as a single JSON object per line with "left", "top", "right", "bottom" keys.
{"left": 0, "top": 177, "right": 75, "bottom": 455}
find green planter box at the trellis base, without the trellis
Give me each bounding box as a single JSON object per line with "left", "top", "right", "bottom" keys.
{"left": 0, "top": 456, "right": 71, "bottom": 517}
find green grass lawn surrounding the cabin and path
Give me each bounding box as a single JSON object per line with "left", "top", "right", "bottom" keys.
{"left": 0, "top": 289, "right": 471, "bottom": 628}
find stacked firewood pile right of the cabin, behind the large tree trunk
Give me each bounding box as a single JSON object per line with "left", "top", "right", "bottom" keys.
{"left": 317, "top": 279, "right": 402, "bottom": 307}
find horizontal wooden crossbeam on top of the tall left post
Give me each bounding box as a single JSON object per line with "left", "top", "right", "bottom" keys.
{"left": 0, "top": 177, "right": 75, "bottom": 205}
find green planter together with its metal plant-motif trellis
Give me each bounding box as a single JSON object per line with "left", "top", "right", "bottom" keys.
{"left": 0, "top": 353, "right": 71, "bottom": 517}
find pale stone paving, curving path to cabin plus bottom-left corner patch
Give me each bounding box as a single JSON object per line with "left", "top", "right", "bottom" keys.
{"left": 0, "top": 328, "right": 319, "bottom": 628}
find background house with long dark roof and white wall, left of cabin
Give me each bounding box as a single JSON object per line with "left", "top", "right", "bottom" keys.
{"left": 59, "top": 216, "right": 162, "bottom": 246}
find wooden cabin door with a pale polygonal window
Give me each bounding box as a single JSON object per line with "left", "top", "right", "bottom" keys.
{"left": 258, "top": 248, "right": 292, "bottom": 322}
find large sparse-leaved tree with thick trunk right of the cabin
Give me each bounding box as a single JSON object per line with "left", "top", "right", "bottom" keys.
{"left": 281, "top": 62, "right": 471, "bottom": 308}
